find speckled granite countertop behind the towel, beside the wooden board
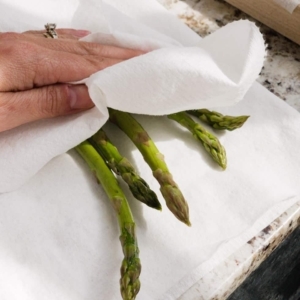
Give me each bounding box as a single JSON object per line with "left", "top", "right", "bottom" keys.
{"left": 160, "top": 0, "right": 300, "bottom": 112}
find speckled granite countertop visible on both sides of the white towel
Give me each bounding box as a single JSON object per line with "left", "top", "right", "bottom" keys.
{"left": 160, "top": 0, "right": 300, "bottom": 300}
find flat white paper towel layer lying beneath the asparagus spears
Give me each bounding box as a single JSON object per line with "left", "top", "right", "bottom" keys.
{"left": 0, "top": 85, "right": 300, "bottom": 300}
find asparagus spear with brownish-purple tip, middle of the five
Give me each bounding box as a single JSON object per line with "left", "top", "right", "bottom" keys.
{"left": 109, "top": 109, "right": 191, "bottom": 226}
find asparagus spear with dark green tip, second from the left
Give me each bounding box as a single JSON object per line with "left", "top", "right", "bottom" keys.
{"left": 89, "top": 129, "right": 161, "bottom": 210}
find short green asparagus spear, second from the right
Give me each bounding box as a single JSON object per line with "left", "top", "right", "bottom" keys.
{"left": 168, "top": 112, "right": 227, "bottom": 169}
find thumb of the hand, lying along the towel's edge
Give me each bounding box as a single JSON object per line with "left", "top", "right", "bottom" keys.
{"left": 0, "top": 84, "right": 94, "bottom": 132}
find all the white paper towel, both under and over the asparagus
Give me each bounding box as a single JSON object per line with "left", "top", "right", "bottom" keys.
{"left": 0, "top": 0, "right": 300, "bottom": 300}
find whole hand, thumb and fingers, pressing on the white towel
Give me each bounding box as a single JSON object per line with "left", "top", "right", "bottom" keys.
{"left": 0, "top": 29, "right": 142, "bottom": 132}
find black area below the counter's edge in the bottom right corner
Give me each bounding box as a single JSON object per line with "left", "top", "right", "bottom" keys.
{"left": 228, "top": 226, "right": 300, "bottom": 300}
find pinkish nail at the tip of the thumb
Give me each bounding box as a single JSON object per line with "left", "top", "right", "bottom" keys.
{"left": 68, "top": 84, "right": 94, "bottom": 110}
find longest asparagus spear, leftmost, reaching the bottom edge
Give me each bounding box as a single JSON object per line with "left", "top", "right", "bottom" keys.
{"left": 75, "top": 141, "right": 141, "bottom": 300}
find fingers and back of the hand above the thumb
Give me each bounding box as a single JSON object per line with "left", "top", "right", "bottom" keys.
{"left": 0, "top": 33, "right": 142, "bottom": 92}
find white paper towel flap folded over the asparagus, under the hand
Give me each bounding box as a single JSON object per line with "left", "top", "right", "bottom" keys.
{"left": 0, "top": 0, "right": 265, "bottom": 192}
